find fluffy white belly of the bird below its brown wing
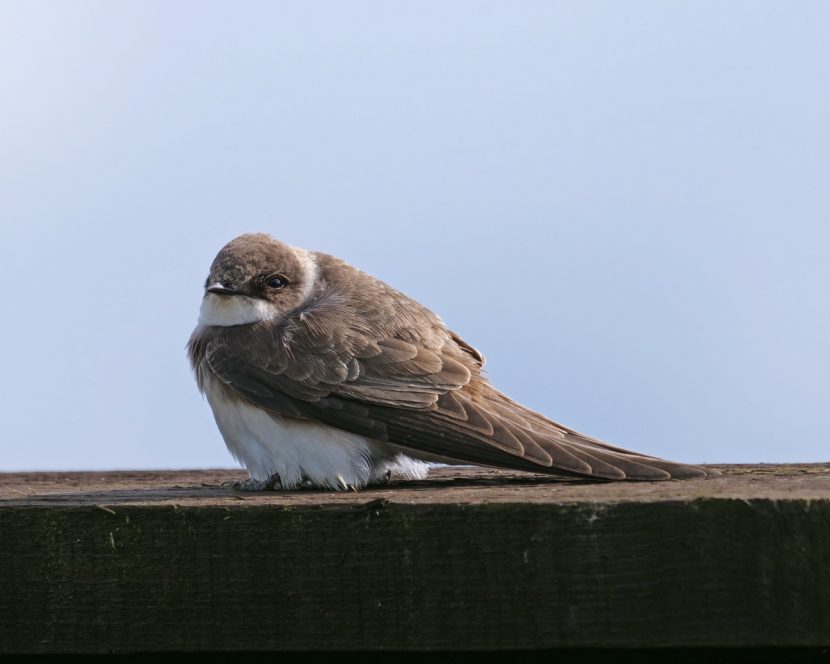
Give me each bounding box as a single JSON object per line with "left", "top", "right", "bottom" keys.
{"left": 203, "top": 374, "right": 429, "bottom": 490}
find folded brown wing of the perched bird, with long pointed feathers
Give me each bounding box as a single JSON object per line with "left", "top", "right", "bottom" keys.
{"left": 204, "top": 324, "right": 707, "bottom": 480}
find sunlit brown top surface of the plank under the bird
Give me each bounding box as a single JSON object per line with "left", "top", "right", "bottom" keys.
{"left": 0, "top": 463, "right": 830, "bottom": 508}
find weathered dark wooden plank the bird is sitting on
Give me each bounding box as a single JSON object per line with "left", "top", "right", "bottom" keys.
{"left": 0, "top": 464, "right": 830, "bottom": 652}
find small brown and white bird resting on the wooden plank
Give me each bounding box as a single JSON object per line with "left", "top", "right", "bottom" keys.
{"left": 187, "top": 233, "right": 716, "bottom": 491}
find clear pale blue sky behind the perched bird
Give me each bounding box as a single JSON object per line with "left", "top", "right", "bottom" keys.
{"left": 0, "top": 0, "right": 830, "bottom": 470}
